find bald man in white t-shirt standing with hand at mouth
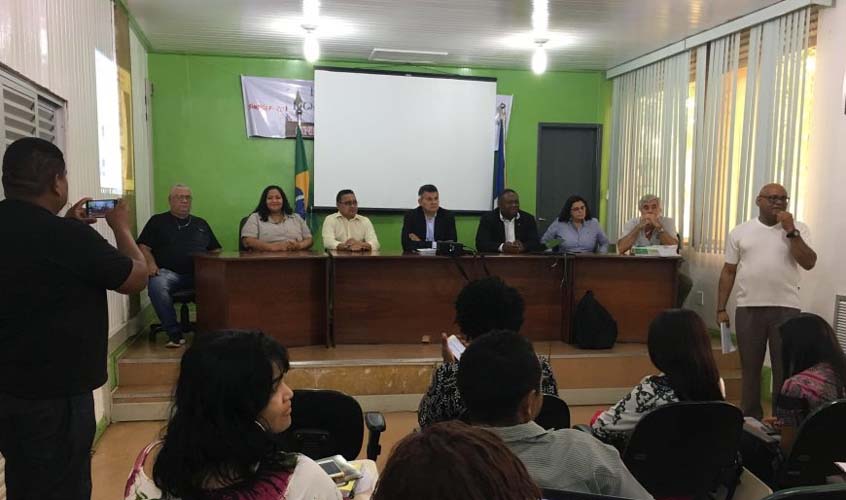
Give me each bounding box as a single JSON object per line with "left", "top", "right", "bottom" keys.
{"left": 717, "top": 184, "right": 817, "bottom": 419}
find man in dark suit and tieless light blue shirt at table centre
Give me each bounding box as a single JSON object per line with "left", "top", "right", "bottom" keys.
{"left": 402, "top": 184, "right": 458, "bottom": 251}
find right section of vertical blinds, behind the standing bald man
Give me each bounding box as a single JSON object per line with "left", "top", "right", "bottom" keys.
{"left": 692, "top": 8, "right": 812, "bottom": 253}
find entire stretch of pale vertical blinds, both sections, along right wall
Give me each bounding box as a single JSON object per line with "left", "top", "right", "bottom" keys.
{"left": 607, "top": 7, "right": 816, "bottom": 253}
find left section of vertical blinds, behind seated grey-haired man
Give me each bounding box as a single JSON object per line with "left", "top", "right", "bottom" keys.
{"left": 606, "top": 51, "right": 690, "bottom": 239}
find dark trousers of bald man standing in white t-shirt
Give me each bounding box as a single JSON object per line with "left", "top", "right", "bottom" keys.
{"left": 734, "top": 307, "right": 799, "bottom": 420}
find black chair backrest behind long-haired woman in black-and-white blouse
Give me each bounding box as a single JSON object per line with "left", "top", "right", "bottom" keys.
{"left": 623, "top": 401, "right": 743, "bottom": 498}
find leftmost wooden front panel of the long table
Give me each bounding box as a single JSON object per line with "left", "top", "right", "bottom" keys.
{"left": 195, "top": 255, "right": 327, "bottom": 347}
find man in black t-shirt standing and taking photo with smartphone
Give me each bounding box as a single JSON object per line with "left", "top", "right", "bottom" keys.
{"left": 0, "top": 137, "right": 147, "bottom": 500}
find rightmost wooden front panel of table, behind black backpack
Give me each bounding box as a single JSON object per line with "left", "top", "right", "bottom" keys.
{"left": 573, "top": 255, "right": 680, "bottom": 343}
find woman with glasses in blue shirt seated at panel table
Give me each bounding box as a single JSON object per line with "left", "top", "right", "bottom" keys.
{"left": 541, "top": 195, "right": 608, "bottom": 253}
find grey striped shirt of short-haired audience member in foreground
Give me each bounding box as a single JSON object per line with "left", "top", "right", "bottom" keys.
{"left": 486, "top": 422, "right": 652, "bottom": 500}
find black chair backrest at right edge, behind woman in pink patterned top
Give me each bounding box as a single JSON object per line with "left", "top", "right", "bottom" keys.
{"left": 777, "top": 399, "right": 846, "bottom": 488}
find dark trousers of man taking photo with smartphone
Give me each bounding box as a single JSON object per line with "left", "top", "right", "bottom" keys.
{"left": 0, "top": 393, "right": 96, "bottom": 500}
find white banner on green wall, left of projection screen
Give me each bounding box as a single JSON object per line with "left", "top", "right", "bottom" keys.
{"left": 241, "top": 75, "right": 314, "bottom": 139}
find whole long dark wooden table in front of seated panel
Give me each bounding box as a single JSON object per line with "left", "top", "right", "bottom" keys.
{"left": 195, "top": 251, "right": 680, "bottom": 346}
